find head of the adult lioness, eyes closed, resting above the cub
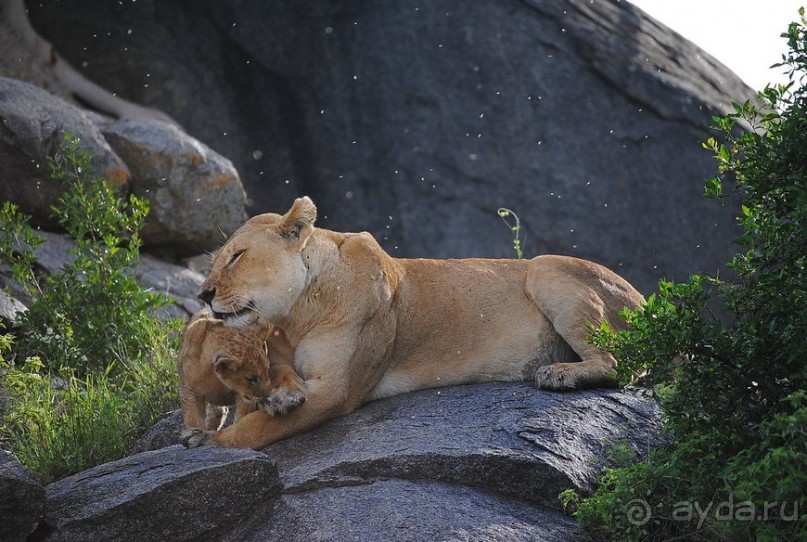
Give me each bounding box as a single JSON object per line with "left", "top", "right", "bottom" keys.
{"left": 198, "top": 198, "right": 316, "bottom": 328}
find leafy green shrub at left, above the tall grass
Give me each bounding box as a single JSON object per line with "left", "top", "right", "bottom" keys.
{"left": 0, "top": 134, "right": 167, "bottom": 375}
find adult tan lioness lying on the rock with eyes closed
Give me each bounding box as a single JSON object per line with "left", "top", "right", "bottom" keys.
{"left": 183, "top": 197, "right": 643, "bottom": 449}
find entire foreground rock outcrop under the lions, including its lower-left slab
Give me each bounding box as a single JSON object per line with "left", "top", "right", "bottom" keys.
{"left": 31, "top": 383, "right": 661, "bottom": 542}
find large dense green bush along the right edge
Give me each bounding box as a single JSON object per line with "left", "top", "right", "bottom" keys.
{"left": 562, "top": 9, "right": 807, "bottom": 541}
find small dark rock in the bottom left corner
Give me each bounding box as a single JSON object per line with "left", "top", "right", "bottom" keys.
{"left": 0, "top": 449, "right": 45, "bottom": 542}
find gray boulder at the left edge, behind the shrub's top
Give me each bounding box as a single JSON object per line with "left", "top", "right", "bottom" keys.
{"left": 0, "top": 77, "right": 129, "bottom": 224}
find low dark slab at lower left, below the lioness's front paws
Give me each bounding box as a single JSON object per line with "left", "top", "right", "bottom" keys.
{"left": 37, "top": 446, "right": 280, "bottom": 541}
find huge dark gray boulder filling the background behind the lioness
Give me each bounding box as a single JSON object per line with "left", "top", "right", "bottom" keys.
{"left": 29, "top": 0, "right": 753, "bottom": 293}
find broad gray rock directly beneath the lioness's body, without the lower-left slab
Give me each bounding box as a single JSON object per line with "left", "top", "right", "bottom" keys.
{"left": 123, "top": 383, "right": 661, "bottom": 541}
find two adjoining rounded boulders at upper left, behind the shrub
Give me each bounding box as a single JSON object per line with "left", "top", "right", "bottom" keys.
{"left": 0, "top": 77, "right": 247, "bottom": 256}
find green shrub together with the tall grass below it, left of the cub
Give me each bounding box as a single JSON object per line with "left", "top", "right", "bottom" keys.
{"left": 0, "top": 134, "right": 179, "bottom": 482}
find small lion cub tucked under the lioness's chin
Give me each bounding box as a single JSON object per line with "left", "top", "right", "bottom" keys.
{"left": 177, "top": 311, "right": 307, "bottom": 429}
